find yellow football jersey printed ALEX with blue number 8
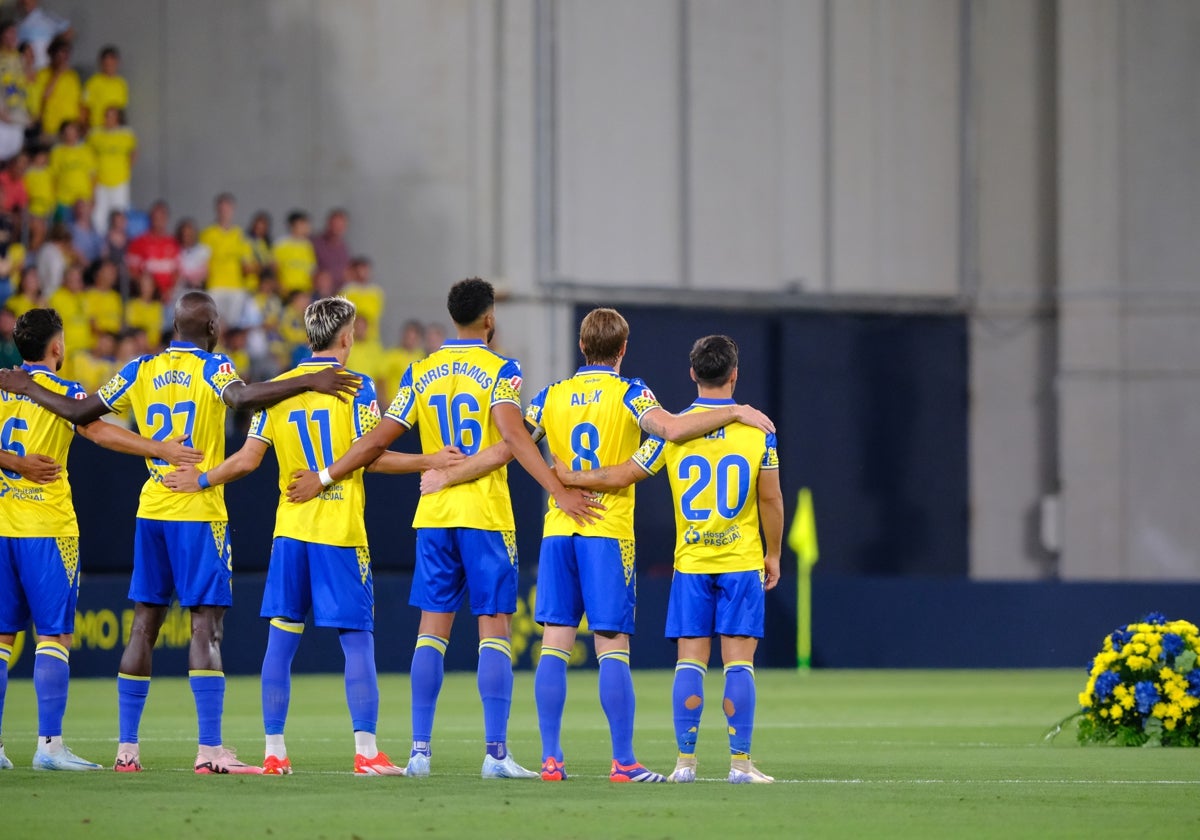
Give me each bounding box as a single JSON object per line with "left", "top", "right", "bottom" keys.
{"left": 526, "top": 365, "right": 661, "bottom": 540}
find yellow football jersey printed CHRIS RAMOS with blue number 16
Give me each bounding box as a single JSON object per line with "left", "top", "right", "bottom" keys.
{"left": 384, "top": 338, "right": 521, "bottom": 530}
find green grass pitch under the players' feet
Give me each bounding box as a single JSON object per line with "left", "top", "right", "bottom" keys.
{"left": 0, "top": 667, "right": 1200, "bottom": 840}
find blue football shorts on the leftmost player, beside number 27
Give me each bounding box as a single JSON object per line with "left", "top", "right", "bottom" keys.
{"left": 0, "top": 536, "right": 79, "bottom": 636}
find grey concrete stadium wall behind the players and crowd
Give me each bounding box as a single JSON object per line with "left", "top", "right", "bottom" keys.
{"left": 42, "top": 0, "right": 1200, "bottom": 580}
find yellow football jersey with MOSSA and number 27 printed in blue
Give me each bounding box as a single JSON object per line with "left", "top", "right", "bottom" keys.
{"left": 100, "top": 341, "right": 241, "bottom": 522}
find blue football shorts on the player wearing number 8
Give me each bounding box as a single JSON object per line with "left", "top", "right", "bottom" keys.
{"left": 534, "top": 534, "right": 637, "bottom": 634}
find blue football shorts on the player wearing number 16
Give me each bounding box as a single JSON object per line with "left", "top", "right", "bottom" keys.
{"left": 408, "top": 528, "right": 517, "bottom": 616}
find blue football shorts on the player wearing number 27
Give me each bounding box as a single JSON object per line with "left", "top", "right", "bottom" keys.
{"left": 130, "top": 517, "right": 233, "bottom": 607}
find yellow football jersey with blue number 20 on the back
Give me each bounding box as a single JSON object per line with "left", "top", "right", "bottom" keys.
{"left": 634, "top": 398, "right": 779, "bottom": 574}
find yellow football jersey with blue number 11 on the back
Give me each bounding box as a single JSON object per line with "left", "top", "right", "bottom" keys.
{"left": 242, "top": 356, "right": 379, "bottom": 547}
